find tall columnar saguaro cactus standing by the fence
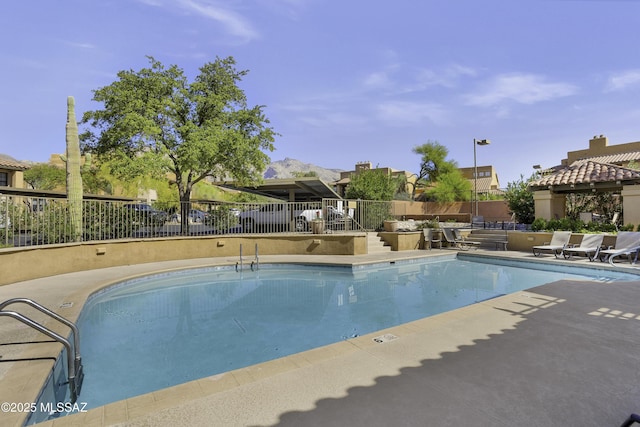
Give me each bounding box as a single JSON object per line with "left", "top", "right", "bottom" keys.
{"left": 66, "top": 96, "right": 82, "bottom": 242}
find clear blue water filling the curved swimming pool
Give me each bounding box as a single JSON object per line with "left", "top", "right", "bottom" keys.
{"left": 56, "top": 256, "right": 638, "bottom": 407}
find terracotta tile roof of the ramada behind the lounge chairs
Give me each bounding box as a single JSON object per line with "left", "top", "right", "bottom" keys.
{"left": 529, "top": 160, "right": 640, "bottom": 187}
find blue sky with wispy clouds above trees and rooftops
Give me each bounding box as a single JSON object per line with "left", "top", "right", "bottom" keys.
{"left": 0, "top": 0, "right": 640, "bottom": 187}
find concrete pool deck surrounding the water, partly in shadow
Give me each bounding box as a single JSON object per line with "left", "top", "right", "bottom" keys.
{"left": 0, "top": 250, "right": 640, "bottom": 427}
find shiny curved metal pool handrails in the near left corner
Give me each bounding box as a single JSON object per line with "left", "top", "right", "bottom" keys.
{"left": 0, "top": 298, "right": 84, "bottom": 403}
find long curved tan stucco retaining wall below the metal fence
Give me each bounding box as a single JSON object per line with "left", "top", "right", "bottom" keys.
{"left": 0, "top": 233, "right": 367, "bottom": 285}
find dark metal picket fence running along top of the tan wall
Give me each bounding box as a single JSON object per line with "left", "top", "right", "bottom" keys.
{"left": 0, "top": 193, "right": 400, "bottom": 247}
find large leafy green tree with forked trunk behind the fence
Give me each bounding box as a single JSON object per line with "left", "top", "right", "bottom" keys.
{"left": 82, "top": 57, "right": 276, "bottom": 231}
